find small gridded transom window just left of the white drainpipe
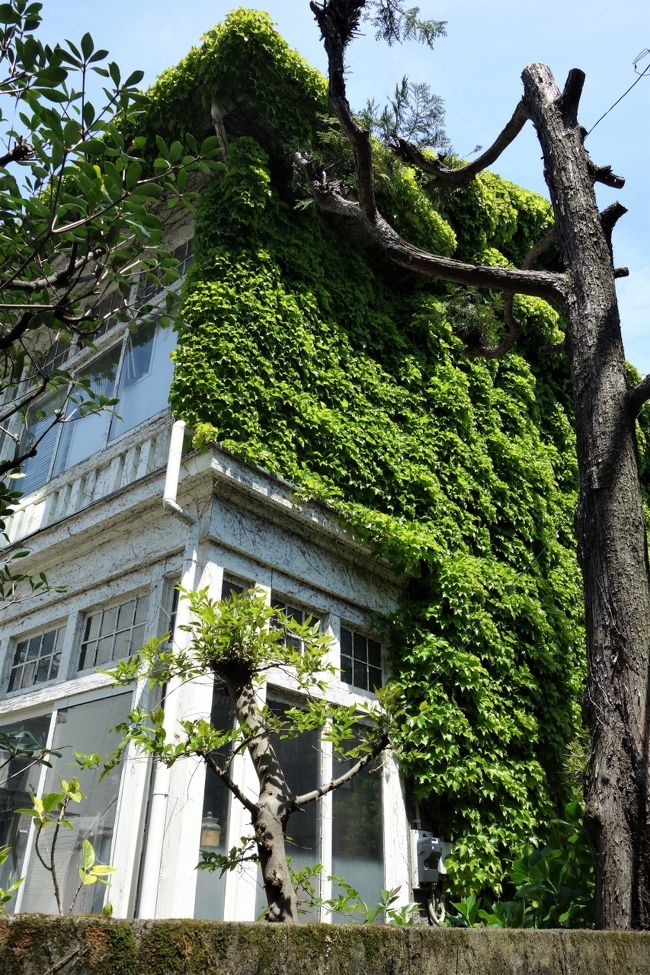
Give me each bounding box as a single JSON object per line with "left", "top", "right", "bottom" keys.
{"left": 79, "top": 593, "right": 149, "bottom": 670}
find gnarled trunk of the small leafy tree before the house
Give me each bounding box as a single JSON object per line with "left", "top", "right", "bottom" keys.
{"left": 217, "top": 667, "right": 298, "bottom": 924}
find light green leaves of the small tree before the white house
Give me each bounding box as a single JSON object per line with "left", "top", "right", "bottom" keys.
{"left": 110, "top": 589, "right": 391, "bottom": 772}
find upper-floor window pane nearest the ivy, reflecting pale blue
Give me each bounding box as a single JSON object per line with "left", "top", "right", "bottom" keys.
{"left": 108, "top": 322, "right": 176, "bottom": 440}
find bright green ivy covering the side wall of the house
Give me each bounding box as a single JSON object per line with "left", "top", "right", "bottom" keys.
{"left": 147, "top": 10, "right": 583, "bottom": 888}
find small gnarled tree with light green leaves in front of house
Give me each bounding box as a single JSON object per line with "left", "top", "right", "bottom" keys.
{"left": 112, "top": 589, "right": 389, "bottom": 923}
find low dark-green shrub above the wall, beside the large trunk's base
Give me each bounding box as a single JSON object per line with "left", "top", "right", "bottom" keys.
{"left": 448, "top": 802, "right": 595, "bottom": 928}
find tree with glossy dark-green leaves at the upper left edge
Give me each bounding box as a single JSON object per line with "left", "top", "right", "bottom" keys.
{"left": 0, "top": 0, "right": 219, "bottom": 595}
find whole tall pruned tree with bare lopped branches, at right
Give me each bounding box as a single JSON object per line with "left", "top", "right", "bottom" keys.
{"left": 294, "top": 0, "right": 650, "bottom": 928}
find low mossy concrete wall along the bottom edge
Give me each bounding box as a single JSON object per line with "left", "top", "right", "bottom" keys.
{"left": 0, "top": 915, "right": 650, "bottom": 975}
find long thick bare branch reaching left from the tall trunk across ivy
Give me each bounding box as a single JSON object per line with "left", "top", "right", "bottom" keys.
{"left": 294, "top": 153, "right": 566, "bottom": 305}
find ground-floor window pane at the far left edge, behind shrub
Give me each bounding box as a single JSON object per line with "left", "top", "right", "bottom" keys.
{"left": 0, "top": 714, "right": 52, "bottom": 909}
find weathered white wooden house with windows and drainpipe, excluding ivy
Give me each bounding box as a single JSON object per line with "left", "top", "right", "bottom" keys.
{"left": 0, "top": 227, "right": 411, "bottom": 920}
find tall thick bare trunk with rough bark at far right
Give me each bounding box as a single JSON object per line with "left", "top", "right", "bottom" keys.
{"left": 522, "top": 64, "right": 650, "bottom": 928}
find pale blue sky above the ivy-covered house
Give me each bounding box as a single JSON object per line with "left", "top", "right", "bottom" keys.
{"left": 38, "top": 0, "right": 650, "bottom": 373}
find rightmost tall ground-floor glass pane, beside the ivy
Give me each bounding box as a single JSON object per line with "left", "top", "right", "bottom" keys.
{"left": 332, "top": 757, "right": 384, "bottom": 923}
